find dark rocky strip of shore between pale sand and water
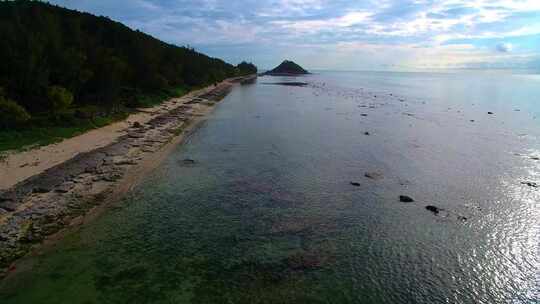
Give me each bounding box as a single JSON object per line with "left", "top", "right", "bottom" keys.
{"left": 0, "top": 75, "right": 256, "bottom": 277}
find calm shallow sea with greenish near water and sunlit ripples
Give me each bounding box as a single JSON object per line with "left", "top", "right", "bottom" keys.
{"left": 0, "top": 72, "right": 540, "bottom": 303}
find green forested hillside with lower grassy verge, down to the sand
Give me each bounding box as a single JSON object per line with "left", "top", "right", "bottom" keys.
{"left": 0, "top": 0, "right": 257, "bottom": 151}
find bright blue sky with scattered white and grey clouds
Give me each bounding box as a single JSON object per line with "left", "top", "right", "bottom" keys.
{"left": 50, "top": 0, "right": 540, "bottom": 70}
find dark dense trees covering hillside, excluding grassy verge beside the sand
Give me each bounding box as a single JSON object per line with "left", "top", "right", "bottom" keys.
{"left": 0, "top": 0, "right": 257, "bottom": 123}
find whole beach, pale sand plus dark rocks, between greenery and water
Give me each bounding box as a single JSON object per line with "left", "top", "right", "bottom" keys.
{"left": 0, "top": 76, "right": 252, "bottom": 270}
